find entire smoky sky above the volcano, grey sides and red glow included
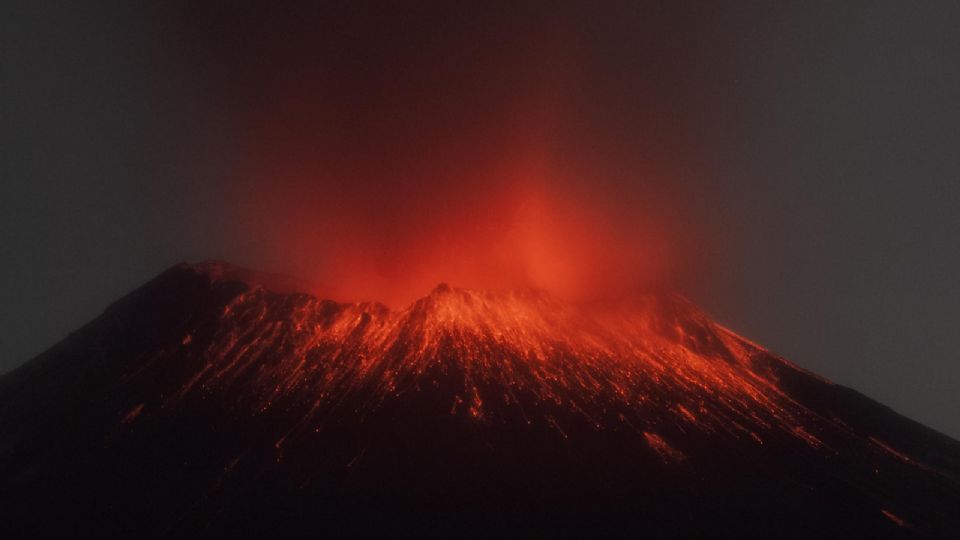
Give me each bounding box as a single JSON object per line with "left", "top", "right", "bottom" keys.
{"left": 0, "top": 1, "right": 960, "bottom": 437}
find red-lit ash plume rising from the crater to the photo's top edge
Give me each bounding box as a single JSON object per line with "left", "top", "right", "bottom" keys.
{"left": 163, "top": 3, "right": 720, "bottom": 304}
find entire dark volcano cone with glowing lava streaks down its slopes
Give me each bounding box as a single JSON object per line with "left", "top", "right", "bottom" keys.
{"left": 0, "top": 263, "right": 960, "bottom": 538}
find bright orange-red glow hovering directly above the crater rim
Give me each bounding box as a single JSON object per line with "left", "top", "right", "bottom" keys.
{"left": 230, "top": 150, "right": 683, "bottom": 307}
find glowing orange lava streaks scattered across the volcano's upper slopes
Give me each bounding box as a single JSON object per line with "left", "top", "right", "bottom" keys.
{"left": 161, "top": 266, "right": 844, "bottom": 454}
